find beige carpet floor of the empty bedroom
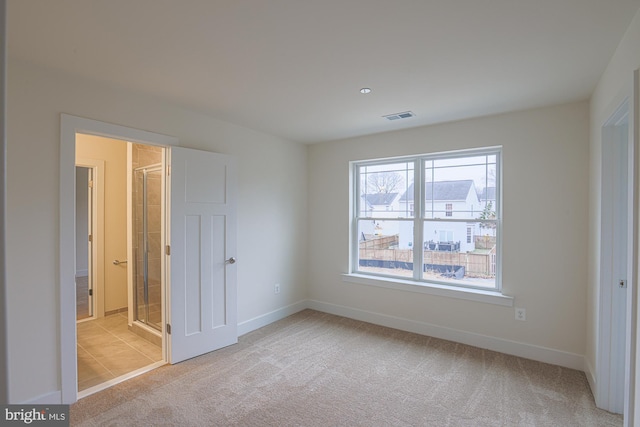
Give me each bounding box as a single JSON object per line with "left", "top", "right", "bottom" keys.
{"left": 71, "top": 310, "right": 622, "bottom": 427}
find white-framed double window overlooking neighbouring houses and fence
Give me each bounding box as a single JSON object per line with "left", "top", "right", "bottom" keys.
{"left": 351, "top": 147, "right": 501, "bottom": 289}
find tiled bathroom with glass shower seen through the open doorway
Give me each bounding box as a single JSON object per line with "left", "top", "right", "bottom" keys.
{"left": 76, "top": 133, "right": 164, "bottom": 397}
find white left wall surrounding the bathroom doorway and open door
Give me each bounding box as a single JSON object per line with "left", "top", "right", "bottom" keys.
{"left": 6, "top": 58, "right": 307, "bottom": 403}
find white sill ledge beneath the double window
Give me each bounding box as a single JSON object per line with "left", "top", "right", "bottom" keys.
{"left": 342, "top": 273, "right": 513, "bottom": 307}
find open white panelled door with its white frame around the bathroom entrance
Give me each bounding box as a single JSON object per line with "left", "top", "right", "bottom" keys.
{"left": 59, "top": 114, "right": 238, "bottom": 404}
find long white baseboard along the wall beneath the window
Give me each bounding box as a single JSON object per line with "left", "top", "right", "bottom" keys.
{"left": 307, "top": 300, "right": 585, "bottom": 371}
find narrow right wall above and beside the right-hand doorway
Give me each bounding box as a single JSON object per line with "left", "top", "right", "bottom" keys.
{"left": 585, "top": 5, "right": 640, "bottom": 412}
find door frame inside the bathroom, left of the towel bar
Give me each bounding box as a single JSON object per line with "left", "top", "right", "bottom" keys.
{"left": 74, "top": 158, "right": 105, "bottom": 320}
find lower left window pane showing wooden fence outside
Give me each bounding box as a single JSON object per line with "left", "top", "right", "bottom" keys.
{"left": 358, "top": 219, "right": 413, "bottom": 278}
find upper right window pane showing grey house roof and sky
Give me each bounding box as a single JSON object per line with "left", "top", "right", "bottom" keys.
{"left": 424, "top": 155, "right": 497, "bottom": 219}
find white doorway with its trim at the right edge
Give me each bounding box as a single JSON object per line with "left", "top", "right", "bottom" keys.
{"left": 596, "top": 100, "right": 633, "bottom": 414}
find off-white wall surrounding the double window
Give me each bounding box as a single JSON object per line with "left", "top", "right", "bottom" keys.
{"left": 309, "top": 102, "right": 589, "bottom": 361}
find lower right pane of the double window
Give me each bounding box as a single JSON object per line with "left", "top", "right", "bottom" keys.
{"left": 422, "top": 221, "right": 497, "bottom": 288}
